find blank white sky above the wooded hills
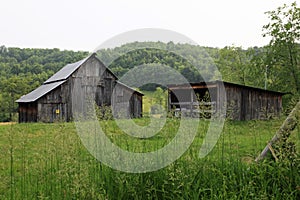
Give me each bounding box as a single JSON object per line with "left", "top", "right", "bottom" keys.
{"left": 0, "top": 0, "right": 299, "bottom": 51}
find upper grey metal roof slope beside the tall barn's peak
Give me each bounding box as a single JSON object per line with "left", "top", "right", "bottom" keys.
{"left": 44, "top": 54, "right": 94, "bottom": 84}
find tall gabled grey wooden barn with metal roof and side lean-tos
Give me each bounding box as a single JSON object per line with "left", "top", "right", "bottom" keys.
{"left": 17, "top": 53, "right": 143, "bottom": 122}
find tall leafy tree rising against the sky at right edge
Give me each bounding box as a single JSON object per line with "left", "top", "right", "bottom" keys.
{"left": 263, "top": 2, "right": 300, "bottom": 94}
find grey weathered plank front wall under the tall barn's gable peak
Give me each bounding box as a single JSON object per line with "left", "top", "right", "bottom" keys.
{"left": 69, "top": 54, "right": 117, "bottom": 119}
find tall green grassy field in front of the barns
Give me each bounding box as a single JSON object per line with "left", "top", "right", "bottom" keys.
{"left": 0, "top": 119, "right": 300, "bottom": 199}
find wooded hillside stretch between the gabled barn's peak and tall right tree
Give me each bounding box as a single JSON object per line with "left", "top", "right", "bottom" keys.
{"left": 98, "top": 42, "right": 262, "bottom": 87}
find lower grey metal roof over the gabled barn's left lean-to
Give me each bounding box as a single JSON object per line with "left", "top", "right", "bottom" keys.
{"left": 16, "top": 80, "right": 66, "bottom": 103}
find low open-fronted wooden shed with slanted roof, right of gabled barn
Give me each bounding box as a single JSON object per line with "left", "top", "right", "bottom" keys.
{"left": 168, "top": 81, "right": 285, "bottom": 120}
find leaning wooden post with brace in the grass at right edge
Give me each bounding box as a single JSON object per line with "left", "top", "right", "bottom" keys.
{"left": 255, "top": 101, "right": 300, "bottom": 162}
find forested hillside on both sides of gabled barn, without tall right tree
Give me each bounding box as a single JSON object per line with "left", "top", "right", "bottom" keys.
{"left": 0, "top": 42, "right": 299, "bottom": 121}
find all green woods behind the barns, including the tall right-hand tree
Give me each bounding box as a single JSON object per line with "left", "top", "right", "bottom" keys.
{"left": 0, "top": 2, "right": 300, "bottom": 121}
